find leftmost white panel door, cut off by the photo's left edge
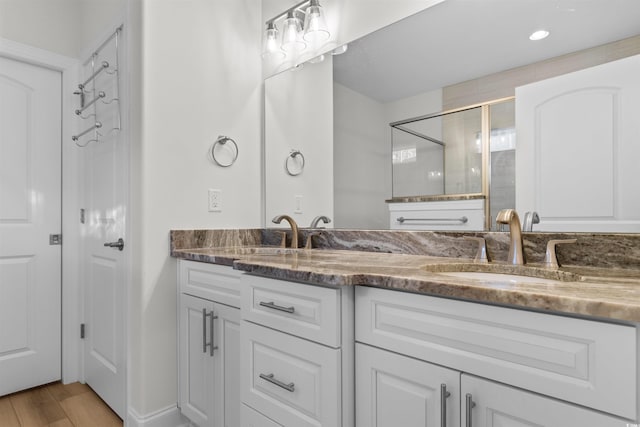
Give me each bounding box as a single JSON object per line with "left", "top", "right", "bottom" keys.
{"left": 0, "top": 57, "right": 62, "bottom": 395}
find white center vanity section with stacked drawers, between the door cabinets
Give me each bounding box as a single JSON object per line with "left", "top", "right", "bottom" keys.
{"left": 240, "top": 274, "right": 354, "bottom": 427}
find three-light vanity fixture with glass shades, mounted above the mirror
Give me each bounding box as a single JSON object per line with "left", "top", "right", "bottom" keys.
{"left": 262, "top": 0, "right": 331, "bottom": 59}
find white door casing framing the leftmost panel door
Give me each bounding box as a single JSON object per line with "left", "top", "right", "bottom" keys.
{"left": 0, "top": 38, "right": 81, "bottom": 383}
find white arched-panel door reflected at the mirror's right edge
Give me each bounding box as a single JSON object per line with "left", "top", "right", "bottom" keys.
{"left": 516, "top": 55, "right": 640, "bottom": 232}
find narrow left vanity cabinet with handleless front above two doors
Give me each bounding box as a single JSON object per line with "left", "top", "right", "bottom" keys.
{"left": 178, "top": 260, "right": 241, "bottom": 427}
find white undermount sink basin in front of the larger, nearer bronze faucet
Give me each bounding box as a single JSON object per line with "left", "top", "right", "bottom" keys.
{"left": 422, "top": 263, "right": 582, "bottom": 284}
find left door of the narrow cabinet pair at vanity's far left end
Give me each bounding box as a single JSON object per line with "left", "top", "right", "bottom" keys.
{"left": 179, "top": 294, "right": 214, "bottom": 427}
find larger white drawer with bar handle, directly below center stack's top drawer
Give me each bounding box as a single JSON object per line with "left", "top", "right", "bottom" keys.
{"left": 240, "top": 322, "right": 341, "bottom": 427}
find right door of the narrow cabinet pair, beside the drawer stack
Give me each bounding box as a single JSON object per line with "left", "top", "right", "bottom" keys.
{"left": 213, "top": 303, "right": 241, "bottom": 427}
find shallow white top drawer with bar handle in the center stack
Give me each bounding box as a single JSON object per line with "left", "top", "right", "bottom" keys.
{"left": 242, "top": 275, "right": 340, "bottom": 348}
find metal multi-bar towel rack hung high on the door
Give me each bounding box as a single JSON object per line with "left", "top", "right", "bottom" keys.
{"left": 71, "top": 26, "right": 122, "bottom": 147}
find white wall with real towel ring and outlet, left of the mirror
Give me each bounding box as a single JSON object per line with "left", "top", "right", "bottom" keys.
{"left": 129, "top": 0, "right": 262, "bottom": 416}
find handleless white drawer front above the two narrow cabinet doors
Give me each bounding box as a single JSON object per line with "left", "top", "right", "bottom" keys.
{"left": 178, "top": 260, "right": 242, "bottom": 308}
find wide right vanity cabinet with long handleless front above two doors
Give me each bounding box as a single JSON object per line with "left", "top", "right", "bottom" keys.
{"left": 355, "top": 287, "right": 638, "bottom": 427}
